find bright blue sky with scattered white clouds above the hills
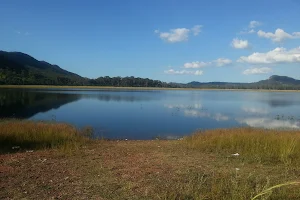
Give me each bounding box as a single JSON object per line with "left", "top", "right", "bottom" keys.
{"left": 0, "top": 0, "right": 300, "bottom": 83}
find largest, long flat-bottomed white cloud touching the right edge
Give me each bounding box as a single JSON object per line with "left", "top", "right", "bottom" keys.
{"left": 238, "top": 47, "right": 300, "bottom": 64}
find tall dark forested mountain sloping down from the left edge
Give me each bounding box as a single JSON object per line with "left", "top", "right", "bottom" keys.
{"left": 0, "top": 51, "right": 87, "bottom": 85}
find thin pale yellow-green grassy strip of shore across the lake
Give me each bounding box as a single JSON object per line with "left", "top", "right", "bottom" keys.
{"left": 0, "top": 85, "right": 300, "bottom": 92}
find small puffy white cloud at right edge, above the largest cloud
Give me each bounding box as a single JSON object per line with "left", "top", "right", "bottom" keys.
{"left": 257, "top": 28, "right": 300, "bottom": 42}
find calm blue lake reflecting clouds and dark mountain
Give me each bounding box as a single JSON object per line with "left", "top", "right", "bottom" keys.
{"left": 0, "top": 89, "right": 300, "bottom": 139}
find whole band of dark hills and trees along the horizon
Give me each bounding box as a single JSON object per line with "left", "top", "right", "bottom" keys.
{"left": 0, "top": 51, "right": 300, "bottom": 90}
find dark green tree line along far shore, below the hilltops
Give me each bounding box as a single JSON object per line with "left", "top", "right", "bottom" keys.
{"left": 0, "top": 67, "right": 300, "bottom": 90}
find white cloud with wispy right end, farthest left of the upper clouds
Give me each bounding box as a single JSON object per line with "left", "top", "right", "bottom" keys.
{"left": 154, "top": 25, "right": 203, "bottom": 43}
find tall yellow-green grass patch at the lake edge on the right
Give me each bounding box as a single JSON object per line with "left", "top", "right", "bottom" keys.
{"left": 185, "top": 128, "right": 300, "bottom": 165}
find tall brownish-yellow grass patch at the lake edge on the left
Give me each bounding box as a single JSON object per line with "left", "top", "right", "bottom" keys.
{"left": 0, "top": 120, "right": 92, "bottom": 152}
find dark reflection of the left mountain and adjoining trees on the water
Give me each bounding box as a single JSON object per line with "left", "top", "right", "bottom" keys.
{"left": 0, "top": 89, "right": 154, "bottom": 118}
